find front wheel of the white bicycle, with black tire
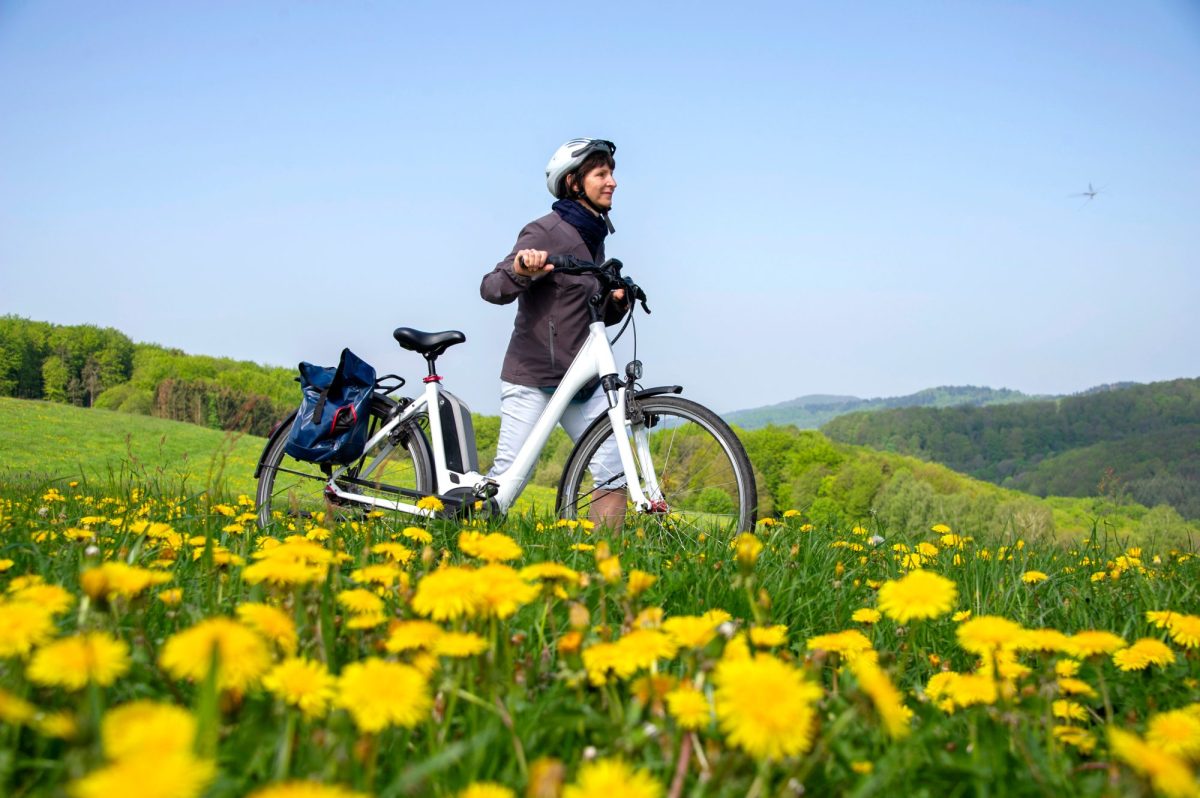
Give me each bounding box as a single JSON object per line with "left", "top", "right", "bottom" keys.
{"left": 558, "top": 396, "right": 758, "bottom": 539}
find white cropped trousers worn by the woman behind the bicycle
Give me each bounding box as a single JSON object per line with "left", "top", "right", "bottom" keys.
{"left": 487, "top": 380, "right": 625, "bottom": 488}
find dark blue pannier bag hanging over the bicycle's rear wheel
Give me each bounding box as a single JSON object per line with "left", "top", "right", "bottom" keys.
{"left": 284, "top": 349, "right": 376, "bottom": 464}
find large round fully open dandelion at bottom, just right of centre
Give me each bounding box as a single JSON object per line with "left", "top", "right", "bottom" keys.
{"left": 713, "top": 655, "right": 821, "bottom": 760}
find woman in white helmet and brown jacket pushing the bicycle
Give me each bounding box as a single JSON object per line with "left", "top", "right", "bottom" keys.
{"left": 479, "top": 138, "right": 625, "bottom": 528}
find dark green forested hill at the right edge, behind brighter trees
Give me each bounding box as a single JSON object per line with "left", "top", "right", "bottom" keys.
{"left": 821, "top": 379, "right": 1200, "bottom": 518}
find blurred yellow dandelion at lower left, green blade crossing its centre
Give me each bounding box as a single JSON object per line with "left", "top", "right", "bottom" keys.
{"left": 158, "top": 618, "right": 271, "bottom": 690}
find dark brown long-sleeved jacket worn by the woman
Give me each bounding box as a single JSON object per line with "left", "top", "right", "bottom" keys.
{"left": 479, "top": 211, "right": 622, "bottom": 388}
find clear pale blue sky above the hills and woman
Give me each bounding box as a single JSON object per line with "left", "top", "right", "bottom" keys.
{"left": 0, "top": 0, "right": 1200, "bottom": 412}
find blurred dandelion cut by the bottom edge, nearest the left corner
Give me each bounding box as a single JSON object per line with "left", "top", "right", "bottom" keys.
{"left": 68, "top": 752, "right": 217, "bottom": 798}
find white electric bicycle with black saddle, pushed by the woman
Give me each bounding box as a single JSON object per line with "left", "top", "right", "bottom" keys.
{"left": 254, "top": 256, "right": 757, "bottom": 534}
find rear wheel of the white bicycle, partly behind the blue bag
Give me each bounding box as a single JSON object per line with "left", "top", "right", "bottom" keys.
{"left": 254, "top": 396, "right": 436, "bottom": 529}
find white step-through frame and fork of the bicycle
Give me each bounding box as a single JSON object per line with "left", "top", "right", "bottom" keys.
{"left": 326, "top": 322, "right": 662, "bottom": 517}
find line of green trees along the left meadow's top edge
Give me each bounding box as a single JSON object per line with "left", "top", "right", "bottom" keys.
{"left": 0, "top": 316, "right": 299, "bottom": 434}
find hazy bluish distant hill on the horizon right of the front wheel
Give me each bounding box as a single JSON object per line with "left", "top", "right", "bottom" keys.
{"left": 721, "top": 385, "right": 1039, "bottom": 430}
